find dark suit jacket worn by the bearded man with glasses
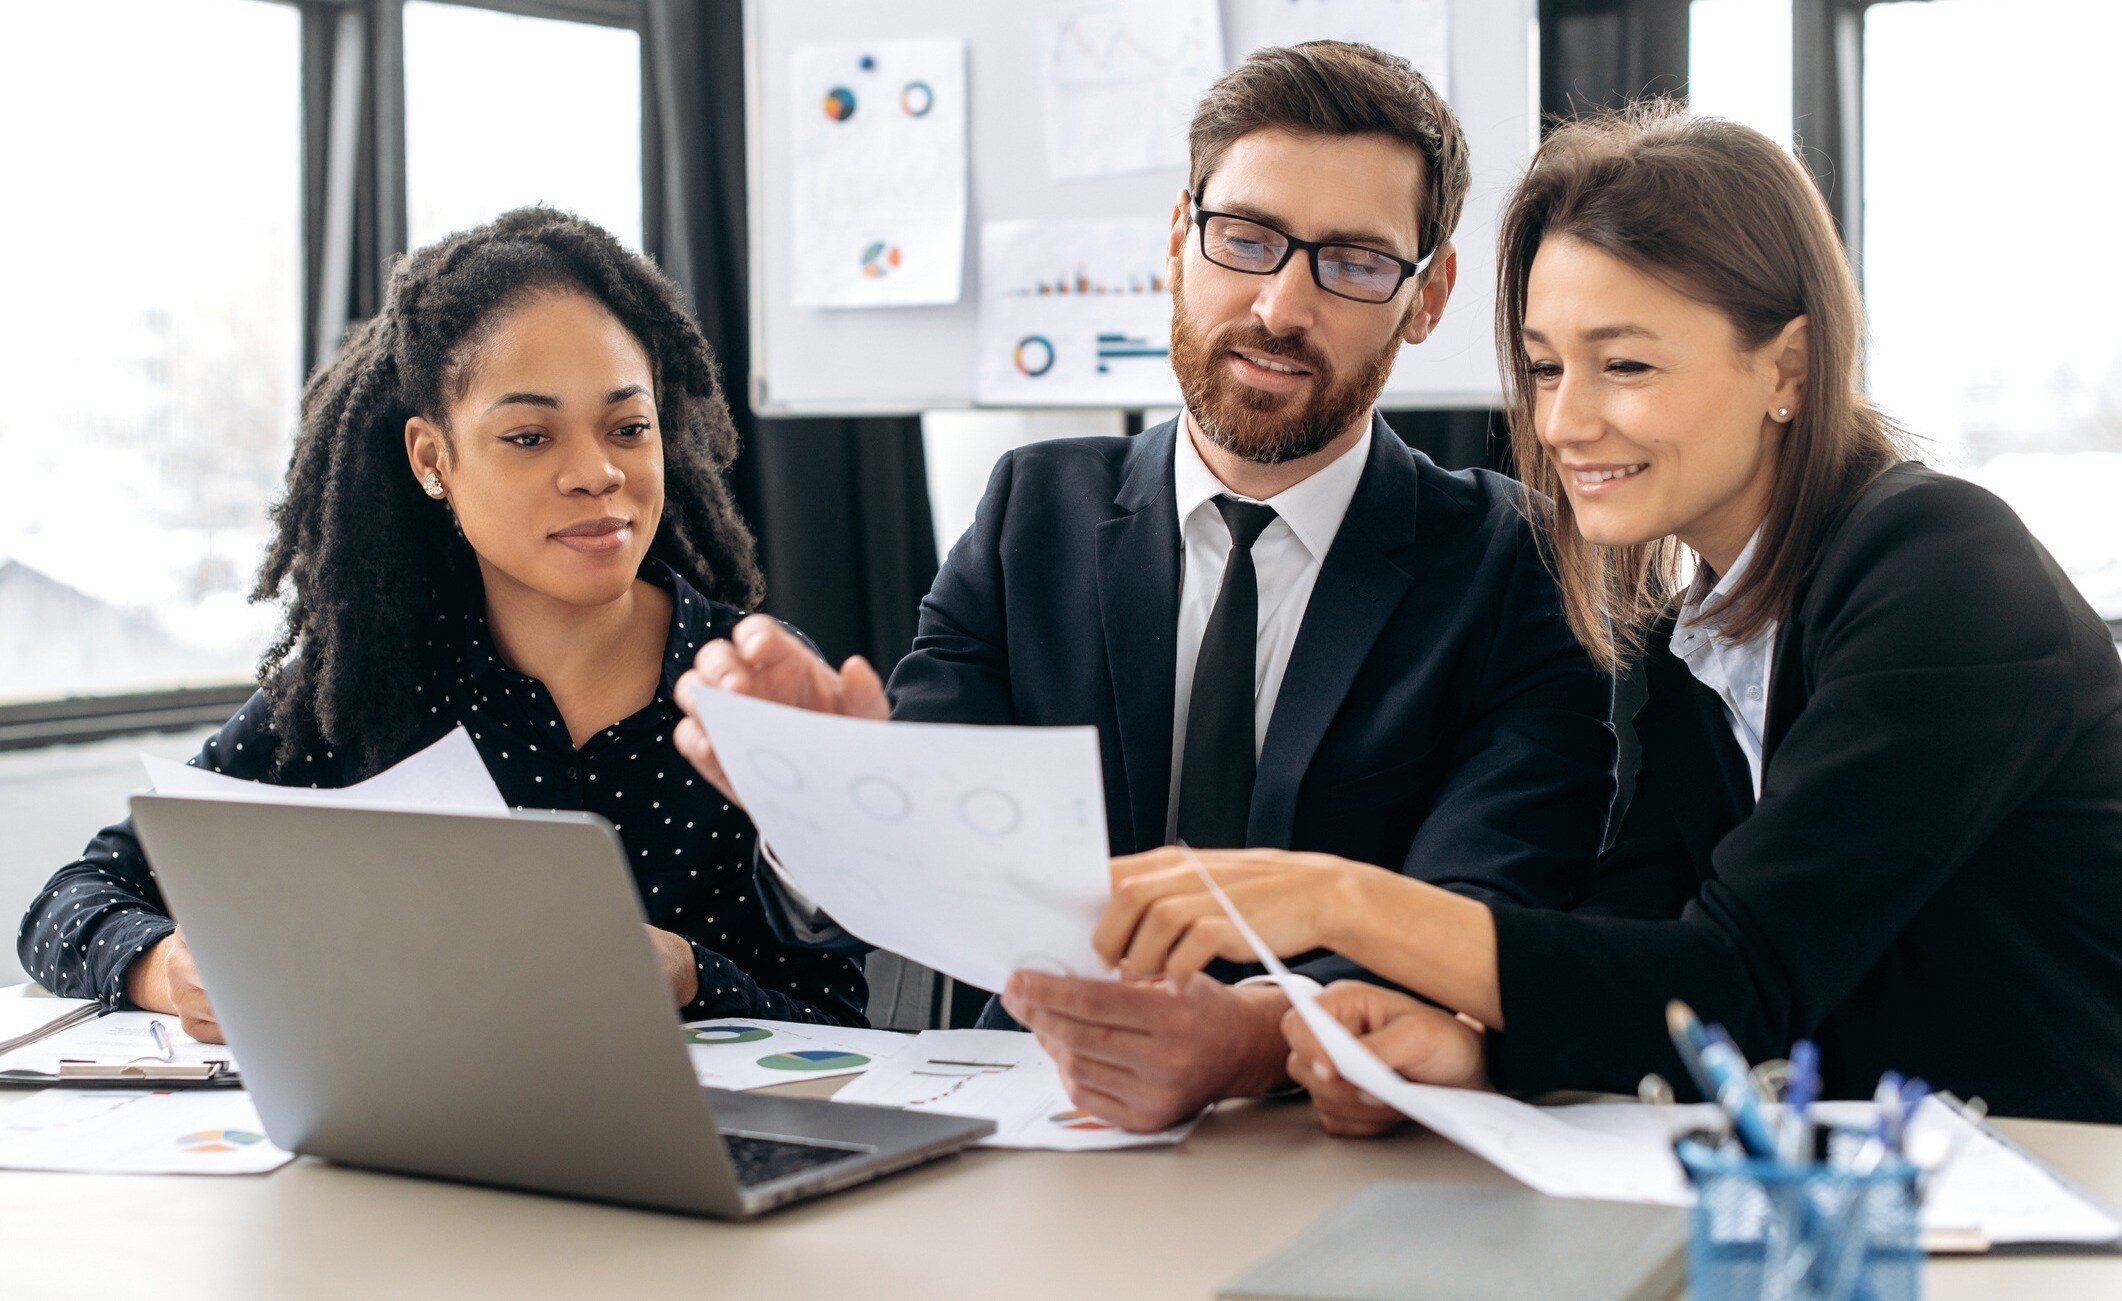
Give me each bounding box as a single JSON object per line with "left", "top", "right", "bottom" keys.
{"left": 870, "top": 420, "right": 1615, "bottom": 976}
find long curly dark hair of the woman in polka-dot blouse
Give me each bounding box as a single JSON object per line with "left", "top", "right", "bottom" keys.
{"left": 250, "top": 208, "right": 764, "bottom": 770}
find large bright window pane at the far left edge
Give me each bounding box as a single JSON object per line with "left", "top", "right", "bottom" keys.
{"left": 0, "top": 0, "right": 301, "bottom": 702}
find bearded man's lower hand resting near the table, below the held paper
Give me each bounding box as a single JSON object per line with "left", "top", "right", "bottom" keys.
{"left": 1002, "top": 972, "right": 1288, "bottom": 1133}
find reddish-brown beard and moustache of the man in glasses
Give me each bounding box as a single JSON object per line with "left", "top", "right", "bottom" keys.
{"left": 1171, "top": 265, "right": 1401, "bottom": 465}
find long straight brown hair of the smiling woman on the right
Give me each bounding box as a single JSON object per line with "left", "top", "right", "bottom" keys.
{"left": 1496, "top": 100, "right": 1906, "bottom": 671}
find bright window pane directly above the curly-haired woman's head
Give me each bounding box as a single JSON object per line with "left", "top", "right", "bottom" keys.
{"left": 405, "top": 0, "right": 641, "bottom": 248}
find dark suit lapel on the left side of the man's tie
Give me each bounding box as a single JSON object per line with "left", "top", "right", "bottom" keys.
{"left": 1097, "top": 420, "right": 1180, "bottom": 853}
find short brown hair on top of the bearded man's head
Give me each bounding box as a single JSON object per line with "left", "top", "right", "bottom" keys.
{"left": 1186, "top": 40, "right": 1471, "bottom": 257}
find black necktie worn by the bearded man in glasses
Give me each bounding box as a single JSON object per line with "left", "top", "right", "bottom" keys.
{"left": 1178, "top": 497, "right": 1275, "bottom": 849}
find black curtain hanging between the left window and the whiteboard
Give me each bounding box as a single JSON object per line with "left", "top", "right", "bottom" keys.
{"left": 641, "top": 0, "right": 936, "bottom": 673}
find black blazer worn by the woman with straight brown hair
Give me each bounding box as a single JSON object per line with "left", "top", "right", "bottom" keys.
{"left": 1490, "top": 463, "right": 2122, "bottom": 1123}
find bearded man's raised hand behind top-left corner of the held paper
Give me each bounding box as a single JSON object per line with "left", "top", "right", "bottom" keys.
{"left": 671, "top": 613, "right": 891, "bottom": 804}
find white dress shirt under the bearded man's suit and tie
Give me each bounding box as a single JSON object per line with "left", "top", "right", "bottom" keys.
{"left": 1165, "top": 418, "right": 1371, "bottom": 840}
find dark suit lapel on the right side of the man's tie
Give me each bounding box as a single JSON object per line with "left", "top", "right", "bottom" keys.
{"left": 1246, "top": 416, "right": 1415, "bottom": 849}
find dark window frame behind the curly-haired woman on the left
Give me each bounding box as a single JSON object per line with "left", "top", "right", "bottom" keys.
{"left": 0, "top": 0, "right": 658, "bottom": 751}
